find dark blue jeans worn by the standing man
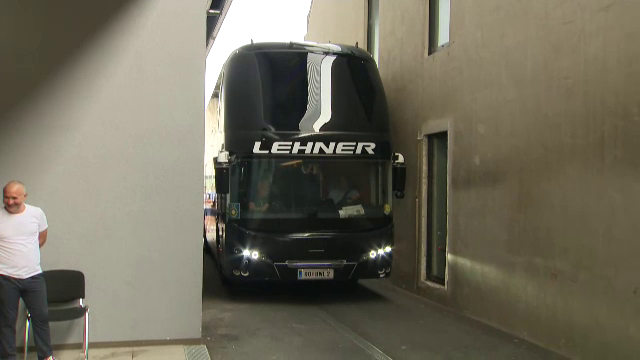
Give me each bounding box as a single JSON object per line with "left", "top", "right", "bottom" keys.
{"left": 0, "top": 274, "right": 53, "bottom": 360}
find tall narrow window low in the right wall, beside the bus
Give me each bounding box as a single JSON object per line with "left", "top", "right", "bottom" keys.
{"left": 423, "top": 131, "right": 449, "bottom": 285}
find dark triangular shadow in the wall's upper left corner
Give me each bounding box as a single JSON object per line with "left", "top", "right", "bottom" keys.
{"left": 0, "top": 0, "right": 136, "bottom": 122}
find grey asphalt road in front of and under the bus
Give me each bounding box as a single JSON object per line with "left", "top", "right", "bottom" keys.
{"left": 202, "top": 253, "right": 563, "bottom": 360}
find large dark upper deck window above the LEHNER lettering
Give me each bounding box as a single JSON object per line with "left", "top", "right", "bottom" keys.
{"left": 223, "top": 51, "right": 388, "bottom": 133}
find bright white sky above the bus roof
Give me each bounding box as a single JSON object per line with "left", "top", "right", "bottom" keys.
{"left": 204, "top": 0, "right": 311, "bottom": 107}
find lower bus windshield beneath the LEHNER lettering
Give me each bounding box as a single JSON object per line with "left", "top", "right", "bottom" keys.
{"left": 229, "top": 158, "right": 391, "bottom": 233}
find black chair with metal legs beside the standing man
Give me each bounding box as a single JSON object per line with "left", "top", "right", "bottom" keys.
{"left": 24, "top": 270, "right": 89, "bottom": 360}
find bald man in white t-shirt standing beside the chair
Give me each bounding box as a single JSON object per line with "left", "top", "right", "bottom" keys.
{"left": 0, "top": 181, "right": 53, "bottom": 360}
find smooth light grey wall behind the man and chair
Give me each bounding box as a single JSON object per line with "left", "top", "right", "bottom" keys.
{"left": 0, "top": 0, "right": 205, "bottom": 343}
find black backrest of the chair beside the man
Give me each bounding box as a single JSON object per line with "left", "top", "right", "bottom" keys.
{"left": 42, "top": 270, "right": 85, "bottom": 304}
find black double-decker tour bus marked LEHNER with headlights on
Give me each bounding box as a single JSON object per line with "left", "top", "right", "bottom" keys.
{"left": 206, "top": 43, "right": 406, "bottom": 282}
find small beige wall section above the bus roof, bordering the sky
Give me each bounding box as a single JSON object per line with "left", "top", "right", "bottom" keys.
{"left": 304, "top": 0, "right": 367, "bottom": 49}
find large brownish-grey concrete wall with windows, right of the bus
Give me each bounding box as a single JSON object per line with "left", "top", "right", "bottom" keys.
{"left": 310, "top": 0, "right": 640, "bottom": 359}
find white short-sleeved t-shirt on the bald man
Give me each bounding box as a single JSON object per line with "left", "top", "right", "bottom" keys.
{"left": 0, "top": 204, "right": 48, "bottom": 279}
